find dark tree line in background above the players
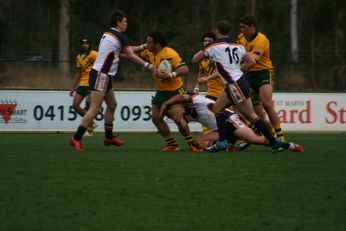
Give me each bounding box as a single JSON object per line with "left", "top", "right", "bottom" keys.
{"left": 0, "top": 0, "right": 346, "bottom": 91}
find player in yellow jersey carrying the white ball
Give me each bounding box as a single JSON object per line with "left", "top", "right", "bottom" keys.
{"left": 140, "top": 32, "right": 203, "bottom": 152}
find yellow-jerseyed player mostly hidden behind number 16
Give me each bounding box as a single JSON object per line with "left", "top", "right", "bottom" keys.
{"left": 194, "top": 31, "right": 225, "bottom": 101}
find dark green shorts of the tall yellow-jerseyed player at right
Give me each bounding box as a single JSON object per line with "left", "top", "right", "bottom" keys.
{"left": 245, "top": 70, "right": 274, "bottom": 106}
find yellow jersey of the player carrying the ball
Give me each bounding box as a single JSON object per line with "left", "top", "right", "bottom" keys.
{"left": 139, "top": 47, "right": 186, "bottom": 91}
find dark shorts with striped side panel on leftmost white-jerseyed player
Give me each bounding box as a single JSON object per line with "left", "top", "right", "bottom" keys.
{"left": 89, "top": 69, "right": 113, "bottom": 93}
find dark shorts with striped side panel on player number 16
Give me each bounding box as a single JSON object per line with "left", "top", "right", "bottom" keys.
{"left": 225, "top": 76, "right": 250, "bottom": 105}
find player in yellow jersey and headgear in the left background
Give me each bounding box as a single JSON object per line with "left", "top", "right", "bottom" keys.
{"left": 70, "top": 37, "right": 97, "bottom": 135}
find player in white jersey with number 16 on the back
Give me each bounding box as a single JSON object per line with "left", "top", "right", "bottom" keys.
{"left": 192, "top": 21, "right": 302, "bottom": 152}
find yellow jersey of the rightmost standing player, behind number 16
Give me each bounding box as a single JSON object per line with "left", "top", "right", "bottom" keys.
{"left": 237, "top": 32, "right": 273, "bottom": 71}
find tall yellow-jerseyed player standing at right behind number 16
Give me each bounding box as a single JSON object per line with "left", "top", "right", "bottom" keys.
{"left": 237, "top": 15, "right": 285, "bottom": 140}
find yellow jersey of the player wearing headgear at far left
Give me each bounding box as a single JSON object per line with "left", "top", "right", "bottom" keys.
{"left": 76, "top": 50, "right": 97, "bottom": 87}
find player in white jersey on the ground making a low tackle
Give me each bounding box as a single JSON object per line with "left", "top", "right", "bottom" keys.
{"left": 160, "top": 93, "right": 302, "bottom": 152}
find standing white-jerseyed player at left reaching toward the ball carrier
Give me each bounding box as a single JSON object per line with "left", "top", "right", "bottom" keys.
{"left": 70, "top": 10, "right": 156, "bottom": 151}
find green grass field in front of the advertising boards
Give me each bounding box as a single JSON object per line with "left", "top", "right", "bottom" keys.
{"left": 0, "top": 133, "right": 346, "bottom": 231}
